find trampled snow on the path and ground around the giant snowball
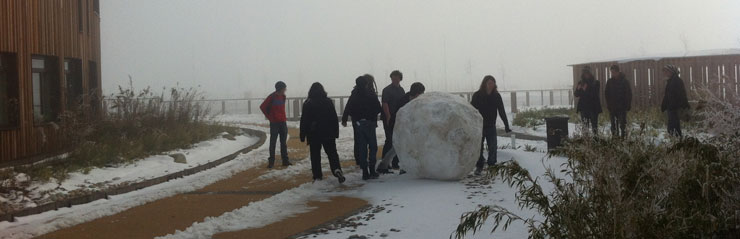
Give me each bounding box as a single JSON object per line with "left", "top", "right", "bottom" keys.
{"left": 162, "top": 116, "right": 566, "bottom": 239}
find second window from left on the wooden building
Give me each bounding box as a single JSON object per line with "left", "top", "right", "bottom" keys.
{"left": 31, "top": 55, "right": 60, "bottom": 124}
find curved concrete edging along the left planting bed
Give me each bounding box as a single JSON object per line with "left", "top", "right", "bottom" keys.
{"left": 0, "top": 128, "right": 267, "bottom": 222}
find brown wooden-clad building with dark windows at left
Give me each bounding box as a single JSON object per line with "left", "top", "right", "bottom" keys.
{"left": 0, "top": 0, "right": 102, "bottom": 164}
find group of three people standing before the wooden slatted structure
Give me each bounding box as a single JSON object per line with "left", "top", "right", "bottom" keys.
{"left": 573, "top": 65, "right": 689, "bottom": 137}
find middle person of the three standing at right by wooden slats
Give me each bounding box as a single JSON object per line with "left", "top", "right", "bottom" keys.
{"left": 604, "top": 65, "right": 632, "bottom": 137}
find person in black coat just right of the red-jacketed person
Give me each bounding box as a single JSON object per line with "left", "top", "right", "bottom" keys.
{"left": 300, "top": 82, "right": 345, "bottom": 183}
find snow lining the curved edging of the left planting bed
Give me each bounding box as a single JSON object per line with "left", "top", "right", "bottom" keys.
{"left": 0, "top": 126, "right": 268, "bottom": 238}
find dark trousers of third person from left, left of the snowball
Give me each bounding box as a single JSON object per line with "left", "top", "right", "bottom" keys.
{"left": 355, "top": 120, "right": 378, "bottom": 171}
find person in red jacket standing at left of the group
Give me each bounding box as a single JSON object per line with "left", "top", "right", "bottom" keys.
{"left": 260, "top": 81, "right": 292, "bottom": 168}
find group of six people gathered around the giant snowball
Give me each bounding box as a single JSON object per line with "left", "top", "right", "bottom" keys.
{"left": 260, "top": 70, "right": 511, "bottom": 183}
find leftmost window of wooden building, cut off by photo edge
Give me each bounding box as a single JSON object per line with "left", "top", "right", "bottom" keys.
{"left": 0, "top": 52, "right": 19, "bottom": 129}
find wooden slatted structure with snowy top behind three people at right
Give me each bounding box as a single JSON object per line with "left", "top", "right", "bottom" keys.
{"left": 570, "top": 49, "right": 740, "bottom": 109}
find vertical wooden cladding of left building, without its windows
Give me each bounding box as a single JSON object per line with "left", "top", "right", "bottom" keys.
{"left": 0, "top": 0, "right": 102, "bottom": 163}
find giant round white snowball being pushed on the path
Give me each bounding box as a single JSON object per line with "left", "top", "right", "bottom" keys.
{"left": 393, "top": 92, "right": 483, "bottom": 180}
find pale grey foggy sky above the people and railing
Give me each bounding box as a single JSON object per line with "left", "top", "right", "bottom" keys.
{"left": 100, "top": 0, "right": 740, "bottom": 98}
